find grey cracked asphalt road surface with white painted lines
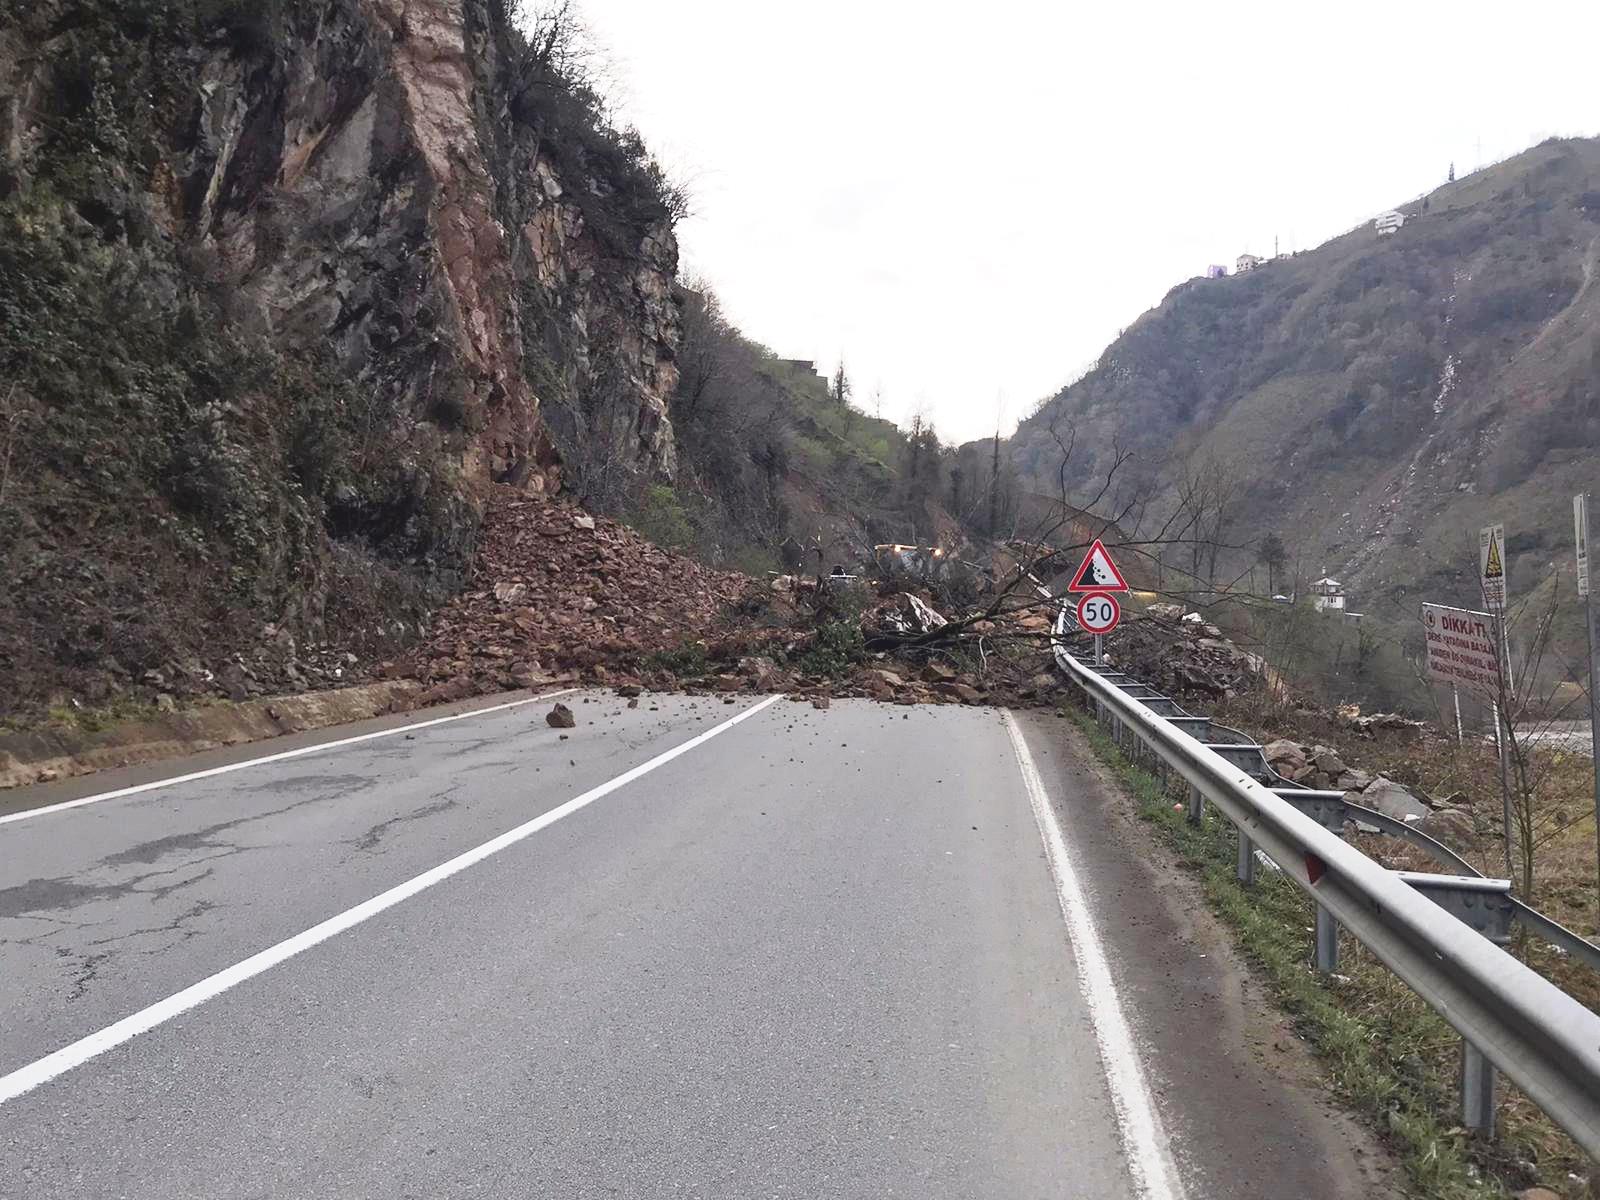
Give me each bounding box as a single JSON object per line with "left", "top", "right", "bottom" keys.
{"left": 0, "top": 693, "right": 1381, "bottom": 1200}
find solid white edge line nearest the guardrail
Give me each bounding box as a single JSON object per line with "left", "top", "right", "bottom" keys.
{"left": 1002, "top": 712, "right": 1184, "bottom": 1200}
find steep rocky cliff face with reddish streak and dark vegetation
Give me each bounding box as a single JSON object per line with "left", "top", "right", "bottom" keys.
{"left": 0, "top": 0, "right": 680, "bottom": 707}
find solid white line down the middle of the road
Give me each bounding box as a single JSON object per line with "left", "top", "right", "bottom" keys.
{"left": 0, "top": 694, "right": 782, "bottom": 1104}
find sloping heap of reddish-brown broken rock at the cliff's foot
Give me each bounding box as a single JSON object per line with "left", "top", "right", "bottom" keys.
{"left": 396, "top": 488, "right": 752, "bottom": 704}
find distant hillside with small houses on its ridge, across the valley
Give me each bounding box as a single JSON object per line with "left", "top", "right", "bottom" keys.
{"left": 1011, "top": 141, "right": 1600, "bottom": 611}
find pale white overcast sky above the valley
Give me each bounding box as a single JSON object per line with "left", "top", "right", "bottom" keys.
{"left": 584, "top": 0, "right": 1600, "bottom": 440}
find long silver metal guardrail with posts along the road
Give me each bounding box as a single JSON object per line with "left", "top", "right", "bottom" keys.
{"left": 1054, "top": 608, "right": 1600, "bottom": 1158}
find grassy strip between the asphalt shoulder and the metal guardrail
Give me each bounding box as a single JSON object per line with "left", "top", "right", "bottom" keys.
{"left": 1067, "top": 706, "right": 1589, "bottom": 1200}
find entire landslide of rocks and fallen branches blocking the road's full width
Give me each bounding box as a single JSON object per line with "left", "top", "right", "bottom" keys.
{"left": 392, "top": 488, "right": 1061, "bottom": 706}
